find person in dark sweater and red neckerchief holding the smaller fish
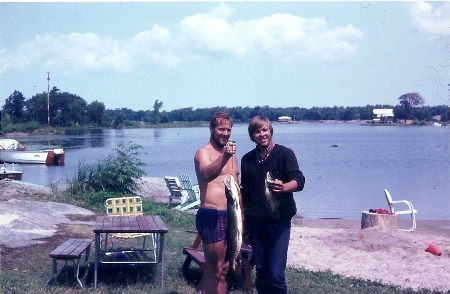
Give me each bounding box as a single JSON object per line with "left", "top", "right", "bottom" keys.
{"left": 241, "top": 116, "right": 305, "bottom": 294}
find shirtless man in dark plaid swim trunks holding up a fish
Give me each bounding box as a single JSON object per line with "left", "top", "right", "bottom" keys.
{"left": 194, "top": 112, "right": 240, "bottom": 294}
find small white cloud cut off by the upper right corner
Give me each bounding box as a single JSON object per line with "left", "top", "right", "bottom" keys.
{"left": 409, "top": 2, "right": 450, "bottom": 38}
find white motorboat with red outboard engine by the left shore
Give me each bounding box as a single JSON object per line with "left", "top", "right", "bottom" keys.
{"left": 0, "top": 139, "right": 64, "bottom": 165}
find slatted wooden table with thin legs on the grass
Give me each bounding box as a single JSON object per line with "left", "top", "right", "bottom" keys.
{"left": 93, "top": 215, "right": 168, "bottom": 288}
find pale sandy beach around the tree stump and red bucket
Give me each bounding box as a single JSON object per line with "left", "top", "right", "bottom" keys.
{"left": 288, "top": 219, "right": 450, "bottom": 291}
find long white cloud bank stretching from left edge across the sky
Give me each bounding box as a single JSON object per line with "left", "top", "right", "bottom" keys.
{"left": 0, "top": 4, "right": 362, "bottom": 72}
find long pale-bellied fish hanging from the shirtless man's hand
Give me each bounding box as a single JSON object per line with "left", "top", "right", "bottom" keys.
{"left": 223, "top": 176, "right": 242, "bottom": 272}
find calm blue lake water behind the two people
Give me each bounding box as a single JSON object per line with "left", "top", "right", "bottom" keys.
{"left": 7, "top": 123, "right": 450, "bottom": 219}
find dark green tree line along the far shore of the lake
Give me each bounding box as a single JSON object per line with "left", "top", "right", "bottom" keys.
{"left": 1, "top": 87, "right": 450, "bottom": 133}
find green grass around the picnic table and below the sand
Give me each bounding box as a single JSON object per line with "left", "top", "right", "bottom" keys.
{"left": 0, "top": 200, "right": 440, "bottom": 294}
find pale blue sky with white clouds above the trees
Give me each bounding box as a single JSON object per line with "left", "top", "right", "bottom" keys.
{"left": 0, "top": 1, "right": 450, "bottom": 111}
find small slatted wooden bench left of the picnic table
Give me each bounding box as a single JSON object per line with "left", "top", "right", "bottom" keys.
{"left": 47, "top": 238, "right": 92, "bottom": 288}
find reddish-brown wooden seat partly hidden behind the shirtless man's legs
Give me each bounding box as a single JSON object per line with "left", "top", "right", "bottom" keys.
{"left": 181, "top": 230, "right": 254, "bottom": 294}
